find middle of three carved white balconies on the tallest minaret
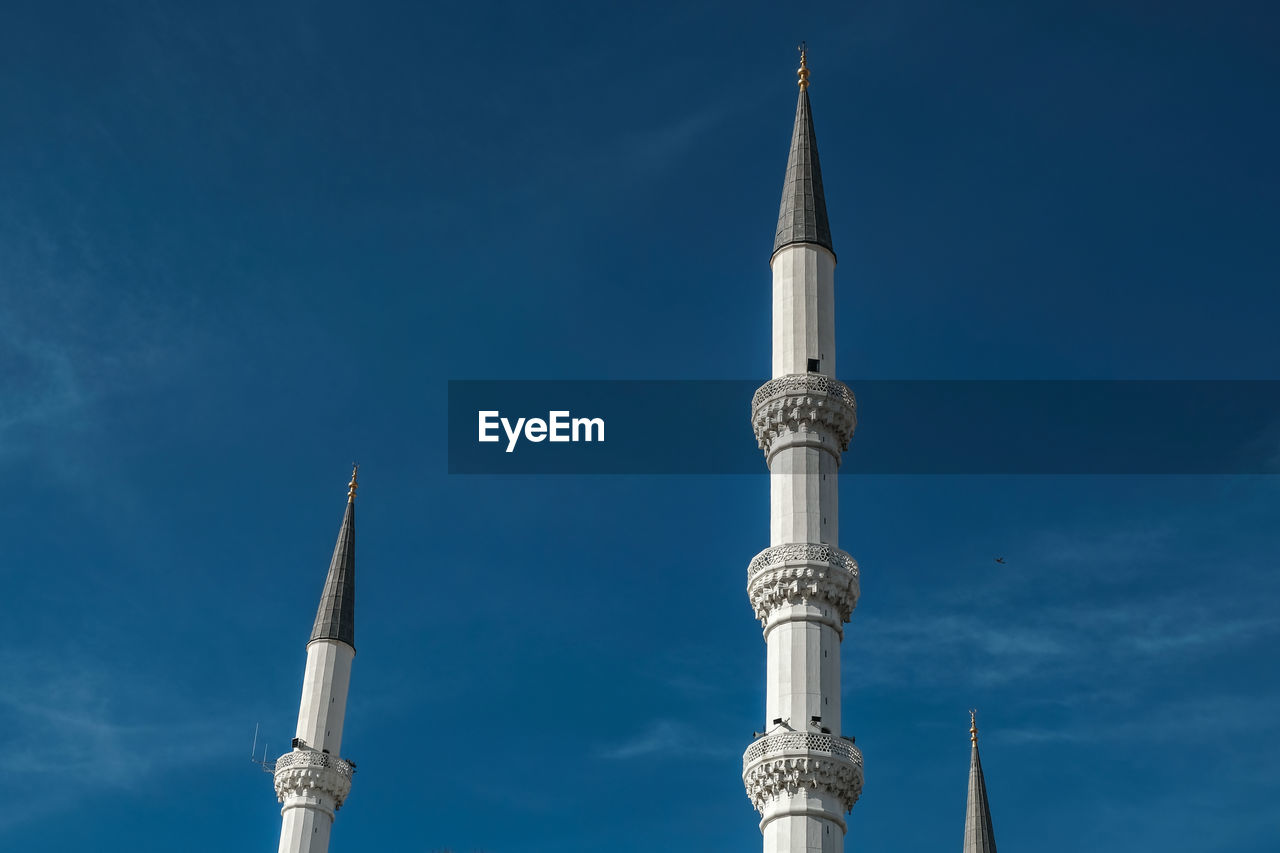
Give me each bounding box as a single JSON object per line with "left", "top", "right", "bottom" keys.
{"left": 746, "top": 543, "right": 859, "bottom": 634}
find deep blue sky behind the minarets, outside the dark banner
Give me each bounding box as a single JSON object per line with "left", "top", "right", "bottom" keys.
{"left": 0, "top": 1, "right": 1280, "bottom": 853}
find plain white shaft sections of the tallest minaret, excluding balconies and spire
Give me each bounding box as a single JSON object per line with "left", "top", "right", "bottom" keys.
{"left": 760, "top": 243, "right": 845, "bottom": 853}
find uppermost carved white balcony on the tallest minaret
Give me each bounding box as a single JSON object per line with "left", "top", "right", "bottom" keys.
{"left": 751, "top": 373, "right": 858, "bottom": 459}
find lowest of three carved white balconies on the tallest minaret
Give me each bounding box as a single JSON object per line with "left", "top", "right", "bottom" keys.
{"left": 742, "top": 731, "right": 863, "bottom": 815}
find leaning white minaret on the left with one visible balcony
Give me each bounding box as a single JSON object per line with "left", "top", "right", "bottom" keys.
{"left": 275, "top": 469, "right": 356, "bottom": 853}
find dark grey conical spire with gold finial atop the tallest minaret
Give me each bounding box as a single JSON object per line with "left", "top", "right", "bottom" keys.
{"left": 773, "top": 49, "right": 836, "bottom": 254}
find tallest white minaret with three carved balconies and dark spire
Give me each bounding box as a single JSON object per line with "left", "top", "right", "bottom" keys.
{"left": 742, "top": 46, "right": 863, "bottom": 853}
